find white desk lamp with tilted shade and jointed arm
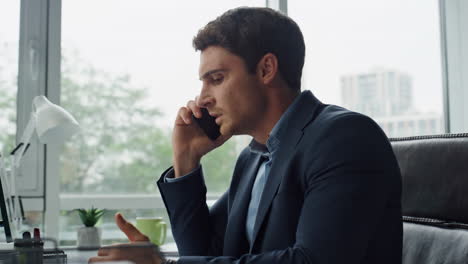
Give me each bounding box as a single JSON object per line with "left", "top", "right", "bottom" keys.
{"left": 3, "top": 95, "right": 80, "bottom": 236}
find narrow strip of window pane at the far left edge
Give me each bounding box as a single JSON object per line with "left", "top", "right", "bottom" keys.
{"left": 0, "top": 1, "right": 20, "bottom": 155}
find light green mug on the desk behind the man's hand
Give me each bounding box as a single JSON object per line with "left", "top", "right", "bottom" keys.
{"left": 136, "top": 217, "right": 167, "bottom": 246}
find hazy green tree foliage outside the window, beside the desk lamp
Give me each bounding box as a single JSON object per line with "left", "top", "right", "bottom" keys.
{"left": 61, "top": 51, "right": 171, "bottom": 193}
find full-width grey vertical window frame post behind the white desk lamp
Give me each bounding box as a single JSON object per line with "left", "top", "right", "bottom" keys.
{"left": 16, "top": 0, "right": 61, "bottom": 237}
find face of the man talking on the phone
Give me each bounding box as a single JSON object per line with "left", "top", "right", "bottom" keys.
{"left": 198, "top": 46, "right": 266, "bottom": 135}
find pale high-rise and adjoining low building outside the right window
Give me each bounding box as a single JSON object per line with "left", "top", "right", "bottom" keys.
{"left": 341, "top": 69, "right": 444, "bottom": 137}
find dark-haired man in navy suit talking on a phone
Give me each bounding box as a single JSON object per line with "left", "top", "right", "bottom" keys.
{"left": 88, "top": 8, "right": 402, "bottom": 264}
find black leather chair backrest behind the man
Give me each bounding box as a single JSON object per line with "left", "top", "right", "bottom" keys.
{"left": 390, "top": 134, "right": 468, "bottom": 264}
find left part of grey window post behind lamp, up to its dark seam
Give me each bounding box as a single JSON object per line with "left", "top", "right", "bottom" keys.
{"left": 16, "top": 0, "right": 48, "bottom": 197}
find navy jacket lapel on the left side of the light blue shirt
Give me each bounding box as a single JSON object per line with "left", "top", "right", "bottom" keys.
{"left": 223, "top": 154, "right": 260, "bottom": 256}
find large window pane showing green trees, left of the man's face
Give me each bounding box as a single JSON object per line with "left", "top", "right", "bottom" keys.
{"left": 60, "top": 0, "right": 265, "bottom": 244}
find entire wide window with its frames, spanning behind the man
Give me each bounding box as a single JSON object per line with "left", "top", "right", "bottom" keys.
{"left": 9, "top": 0, "right": 468, "bottom": 248}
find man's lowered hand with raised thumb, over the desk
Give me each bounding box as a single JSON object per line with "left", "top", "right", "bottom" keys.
{"left": 88, "top": 213, "right": 162, "bottom": 264}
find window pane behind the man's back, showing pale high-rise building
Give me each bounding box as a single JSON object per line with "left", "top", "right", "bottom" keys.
{"left": 288, "top": 0, "right": 444, "bottom": 137}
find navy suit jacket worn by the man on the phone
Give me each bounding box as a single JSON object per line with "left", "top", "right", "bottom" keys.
{"left": 158, "top": 91, "right": 402, "bottom": 264}
